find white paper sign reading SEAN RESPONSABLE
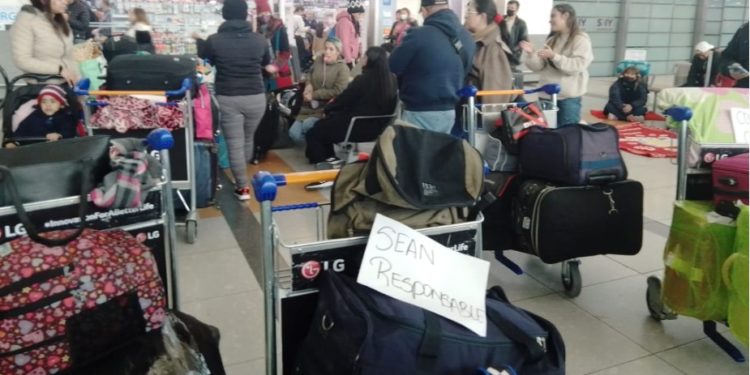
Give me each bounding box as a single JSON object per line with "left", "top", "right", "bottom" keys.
{"left": 357, "top": 215, "right": 490, "bottom": 337}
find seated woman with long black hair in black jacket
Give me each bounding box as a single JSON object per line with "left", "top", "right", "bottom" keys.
{"left": 307, "top": 47, "right": 397, "bottom": 163}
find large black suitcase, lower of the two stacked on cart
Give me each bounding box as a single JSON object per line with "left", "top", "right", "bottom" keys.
{"left": 513, "top": 180, "right": 643, "bottom": 263}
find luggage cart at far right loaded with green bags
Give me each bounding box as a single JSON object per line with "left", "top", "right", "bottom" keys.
{"left": 646, "top": 107, "right": 745, "bottom": 362}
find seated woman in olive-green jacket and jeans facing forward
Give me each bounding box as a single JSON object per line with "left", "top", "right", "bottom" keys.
{"left": 289, "top": 38, "right": 349, "bottom": 143}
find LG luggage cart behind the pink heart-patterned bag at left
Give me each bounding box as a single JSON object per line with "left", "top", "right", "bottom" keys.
{"left": 0, "top": 129, "right": 177, "bottom": 308}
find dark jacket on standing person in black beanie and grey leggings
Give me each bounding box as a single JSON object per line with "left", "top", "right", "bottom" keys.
{"left": 198, "top": 20, "right": 271, "bottom": 96}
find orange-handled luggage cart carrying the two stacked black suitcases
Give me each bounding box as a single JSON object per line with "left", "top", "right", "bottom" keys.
{"left": 459, "top": 84, "right": 583, "bottom": 297}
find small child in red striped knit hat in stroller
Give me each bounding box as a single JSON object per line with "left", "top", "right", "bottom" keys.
{"left": 12, "top": 85, "right": 76, "bottom": 141}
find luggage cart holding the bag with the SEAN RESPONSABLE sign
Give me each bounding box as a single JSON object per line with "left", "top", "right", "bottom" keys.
{"left": 252, "top": 169, "right": 483, "bottom": 375}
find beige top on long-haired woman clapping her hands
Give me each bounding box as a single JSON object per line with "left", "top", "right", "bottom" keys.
{"left": 523, "top": 32, "right": 594, "bottom": 99}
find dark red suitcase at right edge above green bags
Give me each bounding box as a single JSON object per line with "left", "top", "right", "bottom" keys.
{"left": 711, "top": 154, "right": 750, "bottom": 206}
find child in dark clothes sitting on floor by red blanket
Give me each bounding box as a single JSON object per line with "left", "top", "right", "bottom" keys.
{"left": 604, "top": 66, "right": 648, "bottom": 122}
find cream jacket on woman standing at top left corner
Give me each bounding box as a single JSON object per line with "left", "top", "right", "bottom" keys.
{"left": 10, "top": 5, "right": 78, "bottom": 74}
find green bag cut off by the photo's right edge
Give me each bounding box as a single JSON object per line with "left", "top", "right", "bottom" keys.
{"left": 722, "top": 205, "right": 750, "bottom": 346}
